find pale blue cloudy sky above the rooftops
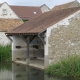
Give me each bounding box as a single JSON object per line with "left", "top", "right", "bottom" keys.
{"left": 0, "top": 0, "right": 80, "bottom": 8}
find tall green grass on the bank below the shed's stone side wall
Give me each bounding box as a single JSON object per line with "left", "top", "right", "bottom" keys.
{"left": 45, "top": 55, "right": 80, "bottom": 79}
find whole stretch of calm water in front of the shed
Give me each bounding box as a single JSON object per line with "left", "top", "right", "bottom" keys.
{"left": 0, "top": 63, "right": 73, "bottom": 80}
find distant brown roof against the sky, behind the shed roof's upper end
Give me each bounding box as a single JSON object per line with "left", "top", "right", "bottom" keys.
{"left": 52, "top": 1, "right": 78, "bottom": 10}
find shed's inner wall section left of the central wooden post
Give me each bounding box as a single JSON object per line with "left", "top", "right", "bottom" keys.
{"left": 12, "top": 36, "right": 27, "bottom": 61}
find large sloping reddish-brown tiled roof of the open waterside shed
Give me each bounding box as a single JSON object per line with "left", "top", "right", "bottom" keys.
{"left": 7, "top": 7, "right": 80, "bottom": 34}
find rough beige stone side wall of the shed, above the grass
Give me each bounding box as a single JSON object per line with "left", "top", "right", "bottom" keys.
{"left": 48, "top": 13, "right": 80, "bottom": 64}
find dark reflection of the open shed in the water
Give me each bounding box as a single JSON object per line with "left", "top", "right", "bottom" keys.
{"left": 12, "top": 64, "right": 44, "bottom": 80}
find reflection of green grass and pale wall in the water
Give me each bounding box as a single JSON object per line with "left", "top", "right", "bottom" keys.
{"left": 0, "top": 62, "right": 12, "bottom": 80}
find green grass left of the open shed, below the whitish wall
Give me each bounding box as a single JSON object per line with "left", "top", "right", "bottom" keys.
{"left": 0, "top": 45, "right": 11, "bottom": 61}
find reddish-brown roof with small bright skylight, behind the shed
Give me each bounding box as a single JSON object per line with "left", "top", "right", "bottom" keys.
{"left": 10, "top": 6, "right": 42, "bottom": 20}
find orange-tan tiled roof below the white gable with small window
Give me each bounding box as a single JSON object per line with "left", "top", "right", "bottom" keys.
{"left": 0, "top": 19, "right": 23, "bottom": 31}
